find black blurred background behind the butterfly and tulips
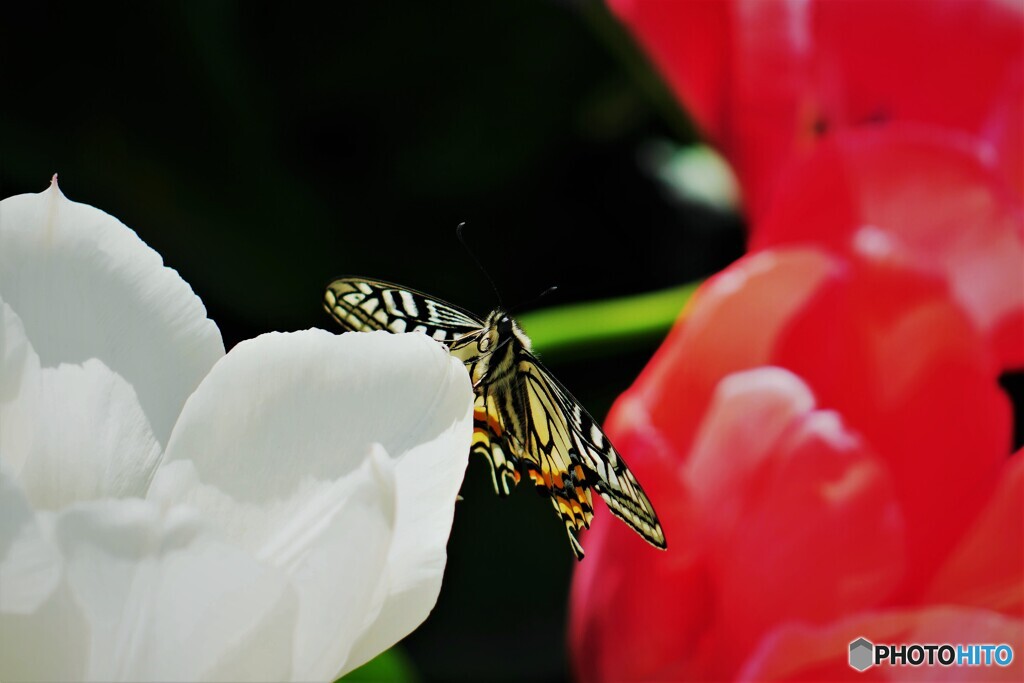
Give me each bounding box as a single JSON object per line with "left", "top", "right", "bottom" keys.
{"left": 0, "top": 0, "right": 743, "bottom": 681}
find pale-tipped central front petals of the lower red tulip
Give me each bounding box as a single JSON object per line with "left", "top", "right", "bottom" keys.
{"left": 689, "top": 368, "right": 904, "bottom": 663}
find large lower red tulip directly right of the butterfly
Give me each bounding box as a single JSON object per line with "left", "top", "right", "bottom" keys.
{"left": 569, "top": 249, "right": 1024, "bottom": 680}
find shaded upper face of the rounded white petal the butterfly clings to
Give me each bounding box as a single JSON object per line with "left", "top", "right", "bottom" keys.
{"left": 155, "top": 330, "right": 472, "bottom": 502}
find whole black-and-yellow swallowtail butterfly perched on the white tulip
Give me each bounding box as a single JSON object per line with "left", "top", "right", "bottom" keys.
{"left": 324, "top": 278, "right": 666, "bottom": 559}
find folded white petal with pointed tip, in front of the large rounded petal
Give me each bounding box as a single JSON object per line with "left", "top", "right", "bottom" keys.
{"left": 150, "top": 445, "right": 396, "bottom": 680}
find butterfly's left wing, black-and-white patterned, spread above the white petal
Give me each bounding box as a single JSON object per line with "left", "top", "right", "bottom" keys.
{"left": 324, "top": 278, "right": 483, "bottom": 346}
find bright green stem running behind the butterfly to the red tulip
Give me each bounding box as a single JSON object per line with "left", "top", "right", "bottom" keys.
{"left": 519, "top": 283, "right": 699, "bottom": 359}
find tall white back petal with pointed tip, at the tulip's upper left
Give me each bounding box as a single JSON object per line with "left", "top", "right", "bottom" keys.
{"left": 0, "top": 182, "right": 224, "bottom": 442}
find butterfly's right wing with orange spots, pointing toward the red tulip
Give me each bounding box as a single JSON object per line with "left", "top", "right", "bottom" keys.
{"left": 519, "top": 351, "right": 666, "bottom": 559}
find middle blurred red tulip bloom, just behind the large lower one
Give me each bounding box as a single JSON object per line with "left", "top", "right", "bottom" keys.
{"left": 751, "top": 124, "right": 1024, "bottom": 368}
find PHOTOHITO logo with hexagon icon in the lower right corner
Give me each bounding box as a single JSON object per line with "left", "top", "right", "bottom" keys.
{"left": 850, "top": 638, "right": 1014, "bottom": 671}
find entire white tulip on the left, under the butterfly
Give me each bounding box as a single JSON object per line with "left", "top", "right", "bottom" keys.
{"left": 0, "top": 181, "right": 472, "bottom": 681}
